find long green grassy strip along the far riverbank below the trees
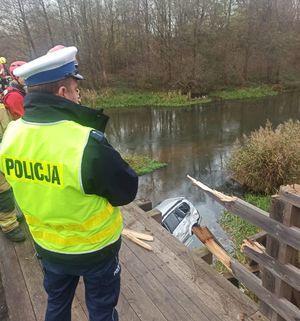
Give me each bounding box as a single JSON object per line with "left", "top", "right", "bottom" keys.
{"left": 82, "top": 85, "right": 286, "bottom": 108}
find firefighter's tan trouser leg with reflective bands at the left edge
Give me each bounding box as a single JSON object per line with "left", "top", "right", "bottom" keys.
{"left": 0, "top": 172, "right": 19, "bottom": 233}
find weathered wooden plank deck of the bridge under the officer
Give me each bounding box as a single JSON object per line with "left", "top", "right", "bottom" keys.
{"left": 0, "top": 203, "right": 265, "bottom": 321}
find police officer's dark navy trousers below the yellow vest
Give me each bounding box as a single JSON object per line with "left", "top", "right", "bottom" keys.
{"left": 42, "top": 256, "right": 121, "bottom": 321}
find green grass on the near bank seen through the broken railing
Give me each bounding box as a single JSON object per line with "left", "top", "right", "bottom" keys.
{"left": 216, "top": 194, "right": 271, "bottom": 272}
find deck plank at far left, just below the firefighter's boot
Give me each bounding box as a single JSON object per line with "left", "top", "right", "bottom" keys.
{"left": 0, "top": 233, "right": 36, "bottom": 321}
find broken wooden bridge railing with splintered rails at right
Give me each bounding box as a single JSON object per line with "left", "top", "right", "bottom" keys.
{"left": 188, "top": 176, "right": 300, "bottom": 321}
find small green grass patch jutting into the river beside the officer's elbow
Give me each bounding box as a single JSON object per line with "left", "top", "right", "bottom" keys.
{"left": 123, "top": 155, "right": 167, "bottom": 176}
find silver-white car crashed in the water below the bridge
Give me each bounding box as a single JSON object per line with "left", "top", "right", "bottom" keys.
{"left": 155, "top": 197, "right": 201, "bottom": 246}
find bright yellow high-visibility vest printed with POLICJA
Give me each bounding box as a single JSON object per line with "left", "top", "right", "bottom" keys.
{"left": 0, "top": 119, "right": 123, "bottom": 254}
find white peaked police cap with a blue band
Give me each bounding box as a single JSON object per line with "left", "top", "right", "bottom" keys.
{"left": 14, "top": 47, "right": 83, "bottom": 87}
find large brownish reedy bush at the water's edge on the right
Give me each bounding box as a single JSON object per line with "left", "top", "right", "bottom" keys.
{"left": 228, "top": 120, "right": 300, "bottom": 193}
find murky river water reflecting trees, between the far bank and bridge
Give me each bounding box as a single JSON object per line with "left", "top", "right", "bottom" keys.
{"left": 106, "top": 93, "right": 300, "bottom": 248}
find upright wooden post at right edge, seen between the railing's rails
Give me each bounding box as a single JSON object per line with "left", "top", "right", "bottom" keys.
{"left": 260, "top": 189, "right": 300, "bottom": 321}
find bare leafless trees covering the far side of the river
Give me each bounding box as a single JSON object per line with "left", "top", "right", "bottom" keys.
{"left": 0, "top": 0, "right": 300, "bottom": 92}
